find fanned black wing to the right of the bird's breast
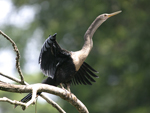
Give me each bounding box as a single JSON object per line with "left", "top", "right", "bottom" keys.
{"left": 71, "top": 62, "right": 98, "bottom": 85}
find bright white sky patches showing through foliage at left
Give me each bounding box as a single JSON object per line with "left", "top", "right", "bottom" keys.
{"left": 0, "top": 0, "right": 39, "bottom": 80}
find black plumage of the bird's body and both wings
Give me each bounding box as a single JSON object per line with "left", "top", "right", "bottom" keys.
{"left": 39, "top": 33, "right": 98, "bottom": 86}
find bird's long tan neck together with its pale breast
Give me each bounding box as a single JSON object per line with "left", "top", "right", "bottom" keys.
{"left": 71, "top": 16, "right": 104, "bottom": 71}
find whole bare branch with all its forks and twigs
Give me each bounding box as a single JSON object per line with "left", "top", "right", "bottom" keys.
{"left": 0, "top": 30, "right": 89, "bottom": 113}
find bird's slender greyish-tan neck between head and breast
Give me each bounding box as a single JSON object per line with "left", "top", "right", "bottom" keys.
{"left": 80, "top": 16, "right": 105, "bottom": 59}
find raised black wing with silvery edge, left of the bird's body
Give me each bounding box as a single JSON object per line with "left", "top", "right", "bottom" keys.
{"left": 39, "top": 33, "right": 70, "bottom": 79}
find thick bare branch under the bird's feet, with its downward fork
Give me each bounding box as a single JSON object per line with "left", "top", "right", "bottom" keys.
{"left": 0, "top": 81, "right": 89, "bottom": 113}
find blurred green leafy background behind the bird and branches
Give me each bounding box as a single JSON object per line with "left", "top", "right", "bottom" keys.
{"left": 0, "top": 0, "right": 150, "bottom": 113}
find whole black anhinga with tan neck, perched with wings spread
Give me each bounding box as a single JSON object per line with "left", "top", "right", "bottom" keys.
{"left": 17, "top": 11, "right": 121, "bottom": 102}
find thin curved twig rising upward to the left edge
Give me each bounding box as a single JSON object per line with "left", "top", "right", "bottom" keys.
{"left": 0, "top": 30, "right": 25, "bottom": 84}
